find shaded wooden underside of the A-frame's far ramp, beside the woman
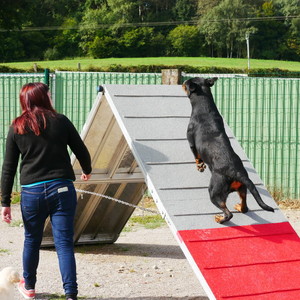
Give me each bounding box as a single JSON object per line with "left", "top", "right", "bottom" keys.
{"left": 42, "top": 94, "right": 146, "bottom": 247}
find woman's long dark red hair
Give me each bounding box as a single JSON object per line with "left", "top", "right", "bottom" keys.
{"left": 12, "top": 82, "right": 56, "bottom": 135}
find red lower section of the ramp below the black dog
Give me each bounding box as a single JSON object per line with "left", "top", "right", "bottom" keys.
{"left": 178, "top": 222, "right": 300, "bottom": 300}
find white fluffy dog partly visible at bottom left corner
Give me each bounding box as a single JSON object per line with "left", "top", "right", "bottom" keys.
{"left": 0, "top": 267, "right": 20, "bottom": 300}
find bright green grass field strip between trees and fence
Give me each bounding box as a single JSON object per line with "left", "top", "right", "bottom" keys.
{"left": 1, "top": 57, "right": 300, "bottom": 71}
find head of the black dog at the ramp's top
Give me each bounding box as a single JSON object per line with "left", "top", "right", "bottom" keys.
{"left": 182, "top": 77, "right": 218, "bottom": 96}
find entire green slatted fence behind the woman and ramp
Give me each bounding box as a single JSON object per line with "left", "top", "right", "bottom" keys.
{"left": 0, "top": 72, "right": 300, "bottom": 199}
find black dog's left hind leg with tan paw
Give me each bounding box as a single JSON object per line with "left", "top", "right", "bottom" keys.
{"left": 208, "top": 175, "right": 233, "bottom": 224}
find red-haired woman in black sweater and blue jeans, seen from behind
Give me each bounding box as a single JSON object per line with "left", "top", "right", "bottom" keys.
{"left": 1, "top": 82, "right": 92, "bottom": 300}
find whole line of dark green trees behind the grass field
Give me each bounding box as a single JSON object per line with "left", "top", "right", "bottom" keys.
{"left": 0, "top": 0, "right": 300, "bottom": 62}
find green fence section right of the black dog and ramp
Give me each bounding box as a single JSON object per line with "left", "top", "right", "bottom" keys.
{"left": 214, "top": 78, "right": 300, "bottom": 198}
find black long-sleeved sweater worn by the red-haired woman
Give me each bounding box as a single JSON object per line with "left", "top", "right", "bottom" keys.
{"left": 1, "top": 114, "right": 92, "bottom": 207}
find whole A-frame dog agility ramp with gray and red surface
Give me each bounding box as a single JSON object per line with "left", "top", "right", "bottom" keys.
{"left": 43, "top": 85, "right": 300, "bottom": 300}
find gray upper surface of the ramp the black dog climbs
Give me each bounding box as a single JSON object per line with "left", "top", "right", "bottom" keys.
{"left": 105, "top": 85, "right": 286, "bottom": 233}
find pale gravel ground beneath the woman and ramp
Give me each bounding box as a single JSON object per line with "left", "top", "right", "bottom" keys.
{"left": 0, "top": 205, "right": 300, "bottom": 300}
